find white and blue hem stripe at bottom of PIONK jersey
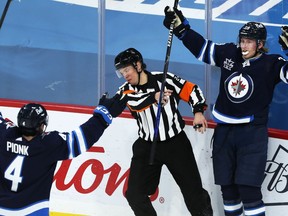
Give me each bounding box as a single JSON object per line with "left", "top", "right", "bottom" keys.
{"left": 0, "top": 200, "right": 49, "bottom": 216}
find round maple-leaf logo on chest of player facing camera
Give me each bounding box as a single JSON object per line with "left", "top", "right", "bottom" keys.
{"left": 225, "top": 72, "right": 254, "bottom": 103}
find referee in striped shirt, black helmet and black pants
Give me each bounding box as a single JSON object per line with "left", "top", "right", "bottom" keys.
{"left": 115, "top": 48, "right": 213, "bottom": 216}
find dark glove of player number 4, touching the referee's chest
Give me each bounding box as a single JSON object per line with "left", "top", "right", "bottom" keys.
{"left": 99, "top": 93, "right": 127, "bottom": 117}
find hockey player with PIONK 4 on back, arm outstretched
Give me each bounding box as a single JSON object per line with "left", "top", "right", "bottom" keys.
{"left": 0, "top": 97, "right": 126, "bottom": 216}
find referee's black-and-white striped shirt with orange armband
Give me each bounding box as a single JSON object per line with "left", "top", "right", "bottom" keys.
{"left": 117, "top": 71, "right": 207, "bottom": 141}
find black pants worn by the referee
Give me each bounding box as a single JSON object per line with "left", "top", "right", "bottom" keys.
{"left": 126, "top": 131, "right": 212, "bottom": 216}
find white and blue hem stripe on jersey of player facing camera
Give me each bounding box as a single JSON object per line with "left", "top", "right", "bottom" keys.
{"left": 212, "top": 106, "right": 254, "bottom": 124}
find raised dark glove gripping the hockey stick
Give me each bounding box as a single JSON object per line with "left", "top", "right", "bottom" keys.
{"left": 163, "top": 6, "right": 190, "bottom": 40}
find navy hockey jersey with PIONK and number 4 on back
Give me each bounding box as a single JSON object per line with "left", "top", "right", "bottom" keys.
{"left": 0, "top": 110, "right": 107, "bottom": 216}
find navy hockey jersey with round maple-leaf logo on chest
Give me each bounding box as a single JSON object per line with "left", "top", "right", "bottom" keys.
{"left": 182, "top": 29, "right": 288, "bottom": 124}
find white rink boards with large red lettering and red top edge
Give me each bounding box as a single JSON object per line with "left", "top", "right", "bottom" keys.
{"left": 0, "top": 101, "right": 288, "bottom": 216}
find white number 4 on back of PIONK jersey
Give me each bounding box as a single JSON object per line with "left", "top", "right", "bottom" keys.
{"left": 5, "top": 155, "right": 24, "bottom": 192}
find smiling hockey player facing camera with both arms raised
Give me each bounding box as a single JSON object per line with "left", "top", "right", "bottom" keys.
{"left": 163, "top": 6, "right": 288, "bottom": 216}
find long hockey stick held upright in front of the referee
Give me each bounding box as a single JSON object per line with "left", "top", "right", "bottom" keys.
{"left": 149, "top": 0, "right": 179, "bottom": 165}
